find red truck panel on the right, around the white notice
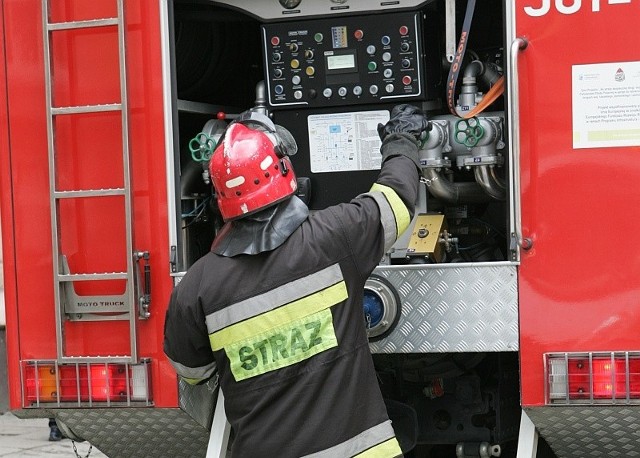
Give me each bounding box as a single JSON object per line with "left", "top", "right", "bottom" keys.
{"left": 516, "top": 0, "right": 640, "bottom": 406}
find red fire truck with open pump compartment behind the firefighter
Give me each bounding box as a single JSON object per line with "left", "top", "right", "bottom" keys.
{"left": 0, "top": 0, "right": 640, "bottom": 458}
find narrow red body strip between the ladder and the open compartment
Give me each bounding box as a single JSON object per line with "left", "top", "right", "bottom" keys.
{"left": 125, "top": 0, "right": 178, "bottom": 407}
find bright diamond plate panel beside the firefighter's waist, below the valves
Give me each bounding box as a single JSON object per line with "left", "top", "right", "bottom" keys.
{"left": 370, "top": 263, "right": 518, "bottom": 353}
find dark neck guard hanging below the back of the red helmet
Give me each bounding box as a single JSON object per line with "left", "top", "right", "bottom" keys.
{"left": 211, "top": 196, "right": 309, "bottom": 257}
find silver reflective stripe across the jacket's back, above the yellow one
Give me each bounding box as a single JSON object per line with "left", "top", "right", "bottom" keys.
{"left": 206, "top": 264, "right": 343, "bottom": 334}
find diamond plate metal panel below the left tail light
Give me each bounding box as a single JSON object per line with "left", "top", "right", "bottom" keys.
{"left": 55, "top": 408, "right": 209, "bottom": 458}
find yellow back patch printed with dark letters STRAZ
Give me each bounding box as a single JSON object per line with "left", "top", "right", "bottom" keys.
{"left": 224, "top": 309, "right": 338, "bottom": 382}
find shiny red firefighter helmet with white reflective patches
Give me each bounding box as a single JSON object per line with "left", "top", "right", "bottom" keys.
{"left": 209, "top": 112, "right": 298, "bottom": 221}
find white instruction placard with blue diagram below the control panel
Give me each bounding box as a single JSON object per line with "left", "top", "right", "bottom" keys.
{"left": 307, "top": 110, "right": 389, "bottom": 173}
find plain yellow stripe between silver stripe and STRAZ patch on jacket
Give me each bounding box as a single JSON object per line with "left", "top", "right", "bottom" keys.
{"left": 209, "top": 281, "right": 348, "bottom": 351}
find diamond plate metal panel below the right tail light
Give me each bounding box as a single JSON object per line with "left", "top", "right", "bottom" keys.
{"left": 525, "top": 406, "right": 640, "bottom": 458}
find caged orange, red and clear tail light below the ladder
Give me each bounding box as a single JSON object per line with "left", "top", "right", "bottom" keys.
{"left": 23, "top": 361, "right": 151, "bottom": 407}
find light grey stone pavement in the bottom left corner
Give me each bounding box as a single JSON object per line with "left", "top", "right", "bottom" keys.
{"left": 0, "top": 412, "right": 107, "bottom": 458}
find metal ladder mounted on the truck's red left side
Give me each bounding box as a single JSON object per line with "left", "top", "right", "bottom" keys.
{"left": 42, "top": 0, "right": 150, "bottom": 363}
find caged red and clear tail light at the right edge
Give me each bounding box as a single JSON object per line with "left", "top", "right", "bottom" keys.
{"left": 545, "top": 352, "right": 640, "bottom": 404}
